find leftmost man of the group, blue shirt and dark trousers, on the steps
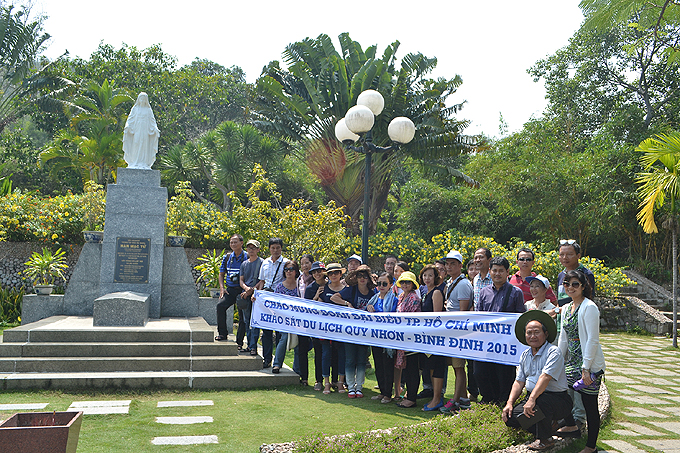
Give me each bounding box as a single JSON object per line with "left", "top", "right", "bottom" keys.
{"left": 215, "top": 234, "right": 248, "bottom": 340}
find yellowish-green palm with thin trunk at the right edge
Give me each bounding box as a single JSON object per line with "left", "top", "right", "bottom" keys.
{"left": 636, "top": 132, "right": 680, "bottom": 348}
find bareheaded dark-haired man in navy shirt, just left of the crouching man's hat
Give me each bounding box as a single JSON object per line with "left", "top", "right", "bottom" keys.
{"left": 475, "top": 256, "right": 526, "bottom": 405}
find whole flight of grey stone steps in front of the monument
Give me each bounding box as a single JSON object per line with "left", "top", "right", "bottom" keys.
{"left": 0, "top": 316, "right": 299, "bottom": 390}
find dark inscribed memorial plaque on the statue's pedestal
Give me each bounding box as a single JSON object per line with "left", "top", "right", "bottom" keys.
{"left": 113, "top": 237, "right": 151, "bottom": 283}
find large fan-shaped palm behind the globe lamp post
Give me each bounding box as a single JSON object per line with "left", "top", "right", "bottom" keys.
{"left": 255, "top": 33, "right": 474, "bottom": 231}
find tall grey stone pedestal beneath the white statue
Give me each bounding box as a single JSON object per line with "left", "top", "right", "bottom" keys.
{"left": 99, "top": 168, "right": 168, "bottom": 318}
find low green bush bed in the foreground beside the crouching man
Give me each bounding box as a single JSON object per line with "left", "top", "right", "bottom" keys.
{"left": 295, "top": 405, "right": 529, "bottom": 453}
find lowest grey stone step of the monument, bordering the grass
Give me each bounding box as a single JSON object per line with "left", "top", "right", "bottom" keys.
{"left": 0, "top": 367, "right": 300, "bottom": 390}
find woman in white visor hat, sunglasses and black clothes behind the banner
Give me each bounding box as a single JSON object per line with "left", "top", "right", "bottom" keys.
{"left": 319, "top": 263, "right": 347, "bottom": 395}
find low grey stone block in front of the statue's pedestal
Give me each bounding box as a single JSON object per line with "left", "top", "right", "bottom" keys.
{"left": 92, "top": 291, "right": 149, "bottom": 327}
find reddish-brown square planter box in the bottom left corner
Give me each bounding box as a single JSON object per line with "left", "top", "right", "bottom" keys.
{"left": 0, "top": 412, "right": 83, "bottom": 453}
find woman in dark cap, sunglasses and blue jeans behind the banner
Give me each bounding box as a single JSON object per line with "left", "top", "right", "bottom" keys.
{"left": 331, "top": 264, "right": 376, "bottom": 398}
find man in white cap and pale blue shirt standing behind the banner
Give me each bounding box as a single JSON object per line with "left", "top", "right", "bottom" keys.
{"left": 440, "top": 250, "right": 474, "bottom": 412}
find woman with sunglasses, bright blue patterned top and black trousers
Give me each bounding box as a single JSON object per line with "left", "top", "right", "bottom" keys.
{"left": 366, "top": 272, "right": 397, "bottom": 404}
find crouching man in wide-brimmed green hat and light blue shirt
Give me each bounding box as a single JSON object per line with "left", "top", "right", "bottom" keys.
{"left": 503, "top": 310, "right": 572, "bottom": 451}
